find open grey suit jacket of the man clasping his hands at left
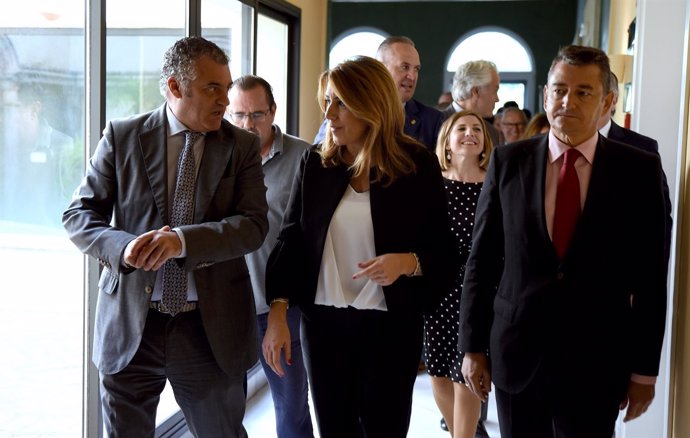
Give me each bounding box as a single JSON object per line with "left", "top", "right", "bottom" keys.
{"left": 63, "top": 105, "right": 268, "bottom": 375}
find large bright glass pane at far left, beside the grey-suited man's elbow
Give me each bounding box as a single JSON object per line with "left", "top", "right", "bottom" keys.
{"left": 0, "top": 0, "right": 85, "bottom": 437}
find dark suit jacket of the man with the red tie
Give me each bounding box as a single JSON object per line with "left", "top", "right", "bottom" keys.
{"left": 459, "top": 135, "right": 667, "bottom": 397}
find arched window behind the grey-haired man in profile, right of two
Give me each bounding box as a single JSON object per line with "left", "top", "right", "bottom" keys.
{"left": 445, "top": 28, "right": 540, "bottom": 113}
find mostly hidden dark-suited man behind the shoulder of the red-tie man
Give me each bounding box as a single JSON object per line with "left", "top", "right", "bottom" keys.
{"left": 597, "top": 72, "right": 673, "bottom": 261}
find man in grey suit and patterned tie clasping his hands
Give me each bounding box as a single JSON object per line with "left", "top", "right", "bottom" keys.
{"left": 63, "top": 37, "right": 268, "bottom": 438}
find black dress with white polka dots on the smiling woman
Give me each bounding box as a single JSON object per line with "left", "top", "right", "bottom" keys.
{"left": 424, "top": 178, "right": 482, "bottom": 382}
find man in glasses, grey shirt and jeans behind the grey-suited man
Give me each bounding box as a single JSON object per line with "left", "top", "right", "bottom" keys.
{"left": 227, "top": 75, "right": 314, "bottom": 438}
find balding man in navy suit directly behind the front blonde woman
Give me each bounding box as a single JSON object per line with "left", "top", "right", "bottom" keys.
{"left": 314, "top": 36, "right": 445, "bottom": 152}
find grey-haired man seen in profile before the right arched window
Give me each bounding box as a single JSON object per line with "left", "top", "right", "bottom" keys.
{"left": 442, "top": 60, "right": 500, "bottom": 146}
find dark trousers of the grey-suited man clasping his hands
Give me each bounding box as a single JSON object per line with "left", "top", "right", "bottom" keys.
{"left": 101, "top": 310, "right": 247, "bottom": 438}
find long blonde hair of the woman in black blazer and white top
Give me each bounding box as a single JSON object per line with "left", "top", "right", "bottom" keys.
{"left": 318, "top": 56, "right": 416, "bottom": 185}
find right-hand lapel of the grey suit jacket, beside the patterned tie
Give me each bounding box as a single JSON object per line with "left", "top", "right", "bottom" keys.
{"left": 194, "top": 126, "right": 236, "bottom": 224}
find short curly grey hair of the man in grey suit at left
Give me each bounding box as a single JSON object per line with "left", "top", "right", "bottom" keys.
{"left": 159, "top": 36, "right": 230, "bottom": 97}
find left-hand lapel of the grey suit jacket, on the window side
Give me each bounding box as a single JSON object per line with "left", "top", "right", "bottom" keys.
{"left": 139, "top": 105, "right": 169, "bottom": 224}
